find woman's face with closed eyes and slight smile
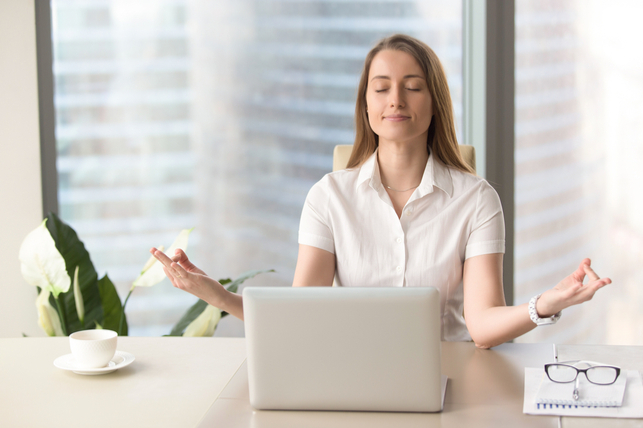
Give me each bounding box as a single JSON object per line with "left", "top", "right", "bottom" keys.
{"left": 366, "top": 50, "right": 433, "bottom": 145}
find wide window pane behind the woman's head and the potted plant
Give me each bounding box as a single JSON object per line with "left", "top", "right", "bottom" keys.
{"left": 52, "top": 0, "right": 462, "bottom": 335}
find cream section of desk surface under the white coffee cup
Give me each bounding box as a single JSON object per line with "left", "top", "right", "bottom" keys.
{"left": 0, "top": 337, "right": 246, "bottom": 428}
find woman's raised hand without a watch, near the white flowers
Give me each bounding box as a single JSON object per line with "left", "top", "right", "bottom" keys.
{"left": 150, "top": 248, "right": 230, "bottom": 309}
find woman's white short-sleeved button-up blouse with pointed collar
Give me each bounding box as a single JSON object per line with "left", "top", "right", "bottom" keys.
{"left": 299, "top": 151, "right": 505, "bottom": 341}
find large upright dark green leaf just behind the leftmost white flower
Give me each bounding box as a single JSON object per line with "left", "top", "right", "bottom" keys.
{"left": 47, "top": 213, "right": 104, "bottom": 334}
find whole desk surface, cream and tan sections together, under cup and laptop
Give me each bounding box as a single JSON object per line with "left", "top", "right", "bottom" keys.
{"left": 0, "top": 337, "right": 643, "bottom": 428}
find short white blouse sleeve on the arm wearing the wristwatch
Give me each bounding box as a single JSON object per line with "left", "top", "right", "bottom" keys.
{"left": 465, "top": 181, "right": 505, "bottom": 259}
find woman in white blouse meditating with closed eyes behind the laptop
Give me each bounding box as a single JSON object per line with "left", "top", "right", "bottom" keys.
{"left": 151, "top": 35, "right": 611, "bottom": 348}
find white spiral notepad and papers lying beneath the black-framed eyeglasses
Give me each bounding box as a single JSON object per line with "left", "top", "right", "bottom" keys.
{"left": 523, "top": 367, "right": 643, "bottom": 418}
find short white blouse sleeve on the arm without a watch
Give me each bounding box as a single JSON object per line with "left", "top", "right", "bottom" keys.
{"left": 299, "top": 178, "right": 335, "bottom": 254}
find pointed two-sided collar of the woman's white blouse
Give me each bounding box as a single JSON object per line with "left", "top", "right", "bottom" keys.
{"left": 356, "top": 149, "right": 453, "bottom": 198}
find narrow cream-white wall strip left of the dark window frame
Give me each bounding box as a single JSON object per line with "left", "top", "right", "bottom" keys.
{"left": 0, "top": 0, "right": 44, "bottom": 337}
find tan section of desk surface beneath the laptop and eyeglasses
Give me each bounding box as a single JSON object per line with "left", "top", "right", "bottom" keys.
{"left": 199, "top": 342, "right": 643, "bottom": 428}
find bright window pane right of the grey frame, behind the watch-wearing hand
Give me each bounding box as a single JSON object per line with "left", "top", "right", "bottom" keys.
{"left": 515, "top": 0, "right": 643, "bottom": 344}
